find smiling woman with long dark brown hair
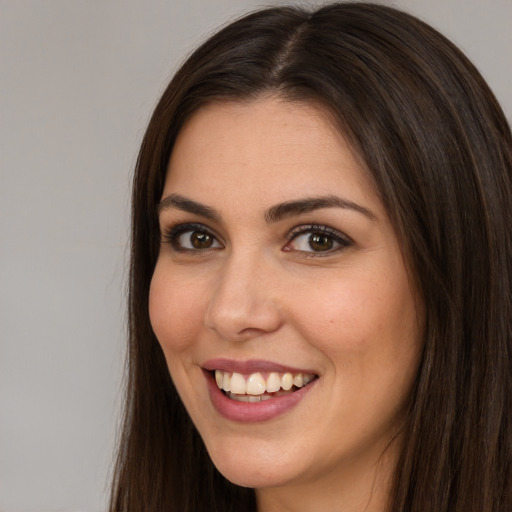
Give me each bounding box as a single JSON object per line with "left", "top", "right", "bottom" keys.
{"left": 111, "top": 3, "right": 512, "bottom": 512}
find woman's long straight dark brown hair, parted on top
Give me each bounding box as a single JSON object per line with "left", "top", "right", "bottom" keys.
{"left": 110, "top": 3, "right": 512, "bottom": 512}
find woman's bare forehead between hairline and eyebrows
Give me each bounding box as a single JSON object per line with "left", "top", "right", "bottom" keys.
{"left": 164, "top": 97, "right": 380, "bottom": 214}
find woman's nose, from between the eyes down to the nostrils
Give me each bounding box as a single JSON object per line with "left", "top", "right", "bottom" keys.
{"left": 205, "top": 251, "right": 282, "bottom": 341}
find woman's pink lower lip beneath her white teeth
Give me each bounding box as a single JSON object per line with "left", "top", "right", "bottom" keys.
{"left": 204, "top": 371, "right": 317, "bottom": 423}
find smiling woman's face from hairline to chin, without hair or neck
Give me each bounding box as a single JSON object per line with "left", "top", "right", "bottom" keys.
{"left": 149, "top": 97, "right": 422, "bottom": 496}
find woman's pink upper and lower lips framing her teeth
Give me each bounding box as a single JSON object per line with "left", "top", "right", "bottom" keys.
{"left": 203, "top": 359, "right": 318, "bottom": 423}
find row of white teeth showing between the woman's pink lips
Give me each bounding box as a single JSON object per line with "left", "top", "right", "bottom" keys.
{"left": 213, "top": 370, "right": 318, "bottom": 403}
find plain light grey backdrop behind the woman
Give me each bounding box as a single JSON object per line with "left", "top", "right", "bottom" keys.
{"left": 0, "top": 0, "right": 512, "bottom": 512}
